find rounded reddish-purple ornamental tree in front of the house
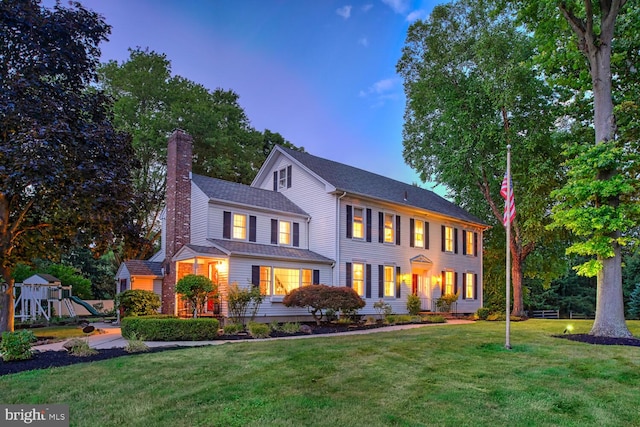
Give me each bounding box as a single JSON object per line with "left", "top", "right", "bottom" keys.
{"left": 282, "top": 285, "right": 366, "bottom": 325}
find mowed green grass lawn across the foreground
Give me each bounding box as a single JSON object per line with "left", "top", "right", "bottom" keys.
{"left": 0, "top": 320, "right": 640, "bottom": 426}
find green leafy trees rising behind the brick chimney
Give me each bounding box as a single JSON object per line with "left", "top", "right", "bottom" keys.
{"left": 99, "top": 48, "right": 296, "bottom": 263}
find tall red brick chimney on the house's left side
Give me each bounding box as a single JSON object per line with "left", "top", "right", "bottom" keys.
{"left": 162, "top": 129, "right": 193, "bottom": 314}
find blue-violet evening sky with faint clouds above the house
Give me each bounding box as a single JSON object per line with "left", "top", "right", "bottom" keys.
{"left": 71, "top": 0, "right": 442, "bottom": 193}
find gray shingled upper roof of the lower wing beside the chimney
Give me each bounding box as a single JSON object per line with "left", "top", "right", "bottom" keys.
{"left": 191, "top": 174, "right": 309, "bottom": 216}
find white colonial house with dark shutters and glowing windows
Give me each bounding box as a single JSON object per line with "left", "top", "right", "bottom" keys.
{"left": 117, "top": 130, "right": 487, "bottom": 319}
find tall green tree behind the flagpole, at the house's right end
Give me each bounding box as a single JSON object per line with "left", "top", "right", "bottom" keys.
{"left": 397, "top": 0, "right": 561, "bottom": 315}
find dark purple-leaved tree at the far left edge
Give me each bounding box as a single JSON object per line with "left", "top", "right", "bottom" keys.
{"left": 0, "top": 0, "right": 135, "bottom": 331}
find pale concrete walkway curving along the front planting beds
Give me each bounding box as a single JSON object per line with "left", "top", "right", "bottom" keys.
{"left": 33, "top": 319, "right": 474, "bottom": 351}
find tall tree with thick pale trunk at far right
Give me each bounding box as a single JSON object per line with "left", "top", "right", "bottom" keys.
{"left": 520, "top": 0, "right": 640, "bottom": 337}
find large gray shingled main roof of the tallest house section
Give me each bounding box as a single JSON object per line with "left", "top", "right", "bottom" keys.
{"left": 279, "top": 146, "right": 485, "bottom": 225}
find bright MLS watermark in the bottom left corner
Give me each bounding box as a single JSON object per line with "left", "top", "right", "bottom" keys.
{"left": 0, "top": 405, "right": 69, "bottom": 427}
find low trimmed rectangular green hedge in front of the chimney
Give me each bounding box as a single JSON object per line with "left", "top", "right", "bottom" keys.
{"left": 121, "top": 317, "right": 220, "bottom": 341}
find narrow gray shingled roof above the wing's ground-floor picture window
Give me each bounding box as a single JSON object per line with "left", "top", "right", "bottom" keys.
{"left": 207, "top": 239, "right": 333, "bottom": 264}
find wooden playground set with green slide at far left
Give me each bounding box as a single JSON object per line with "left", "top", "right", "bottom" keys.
{"left": 13, "top": 273, "right": 100, "bottom": 321}
